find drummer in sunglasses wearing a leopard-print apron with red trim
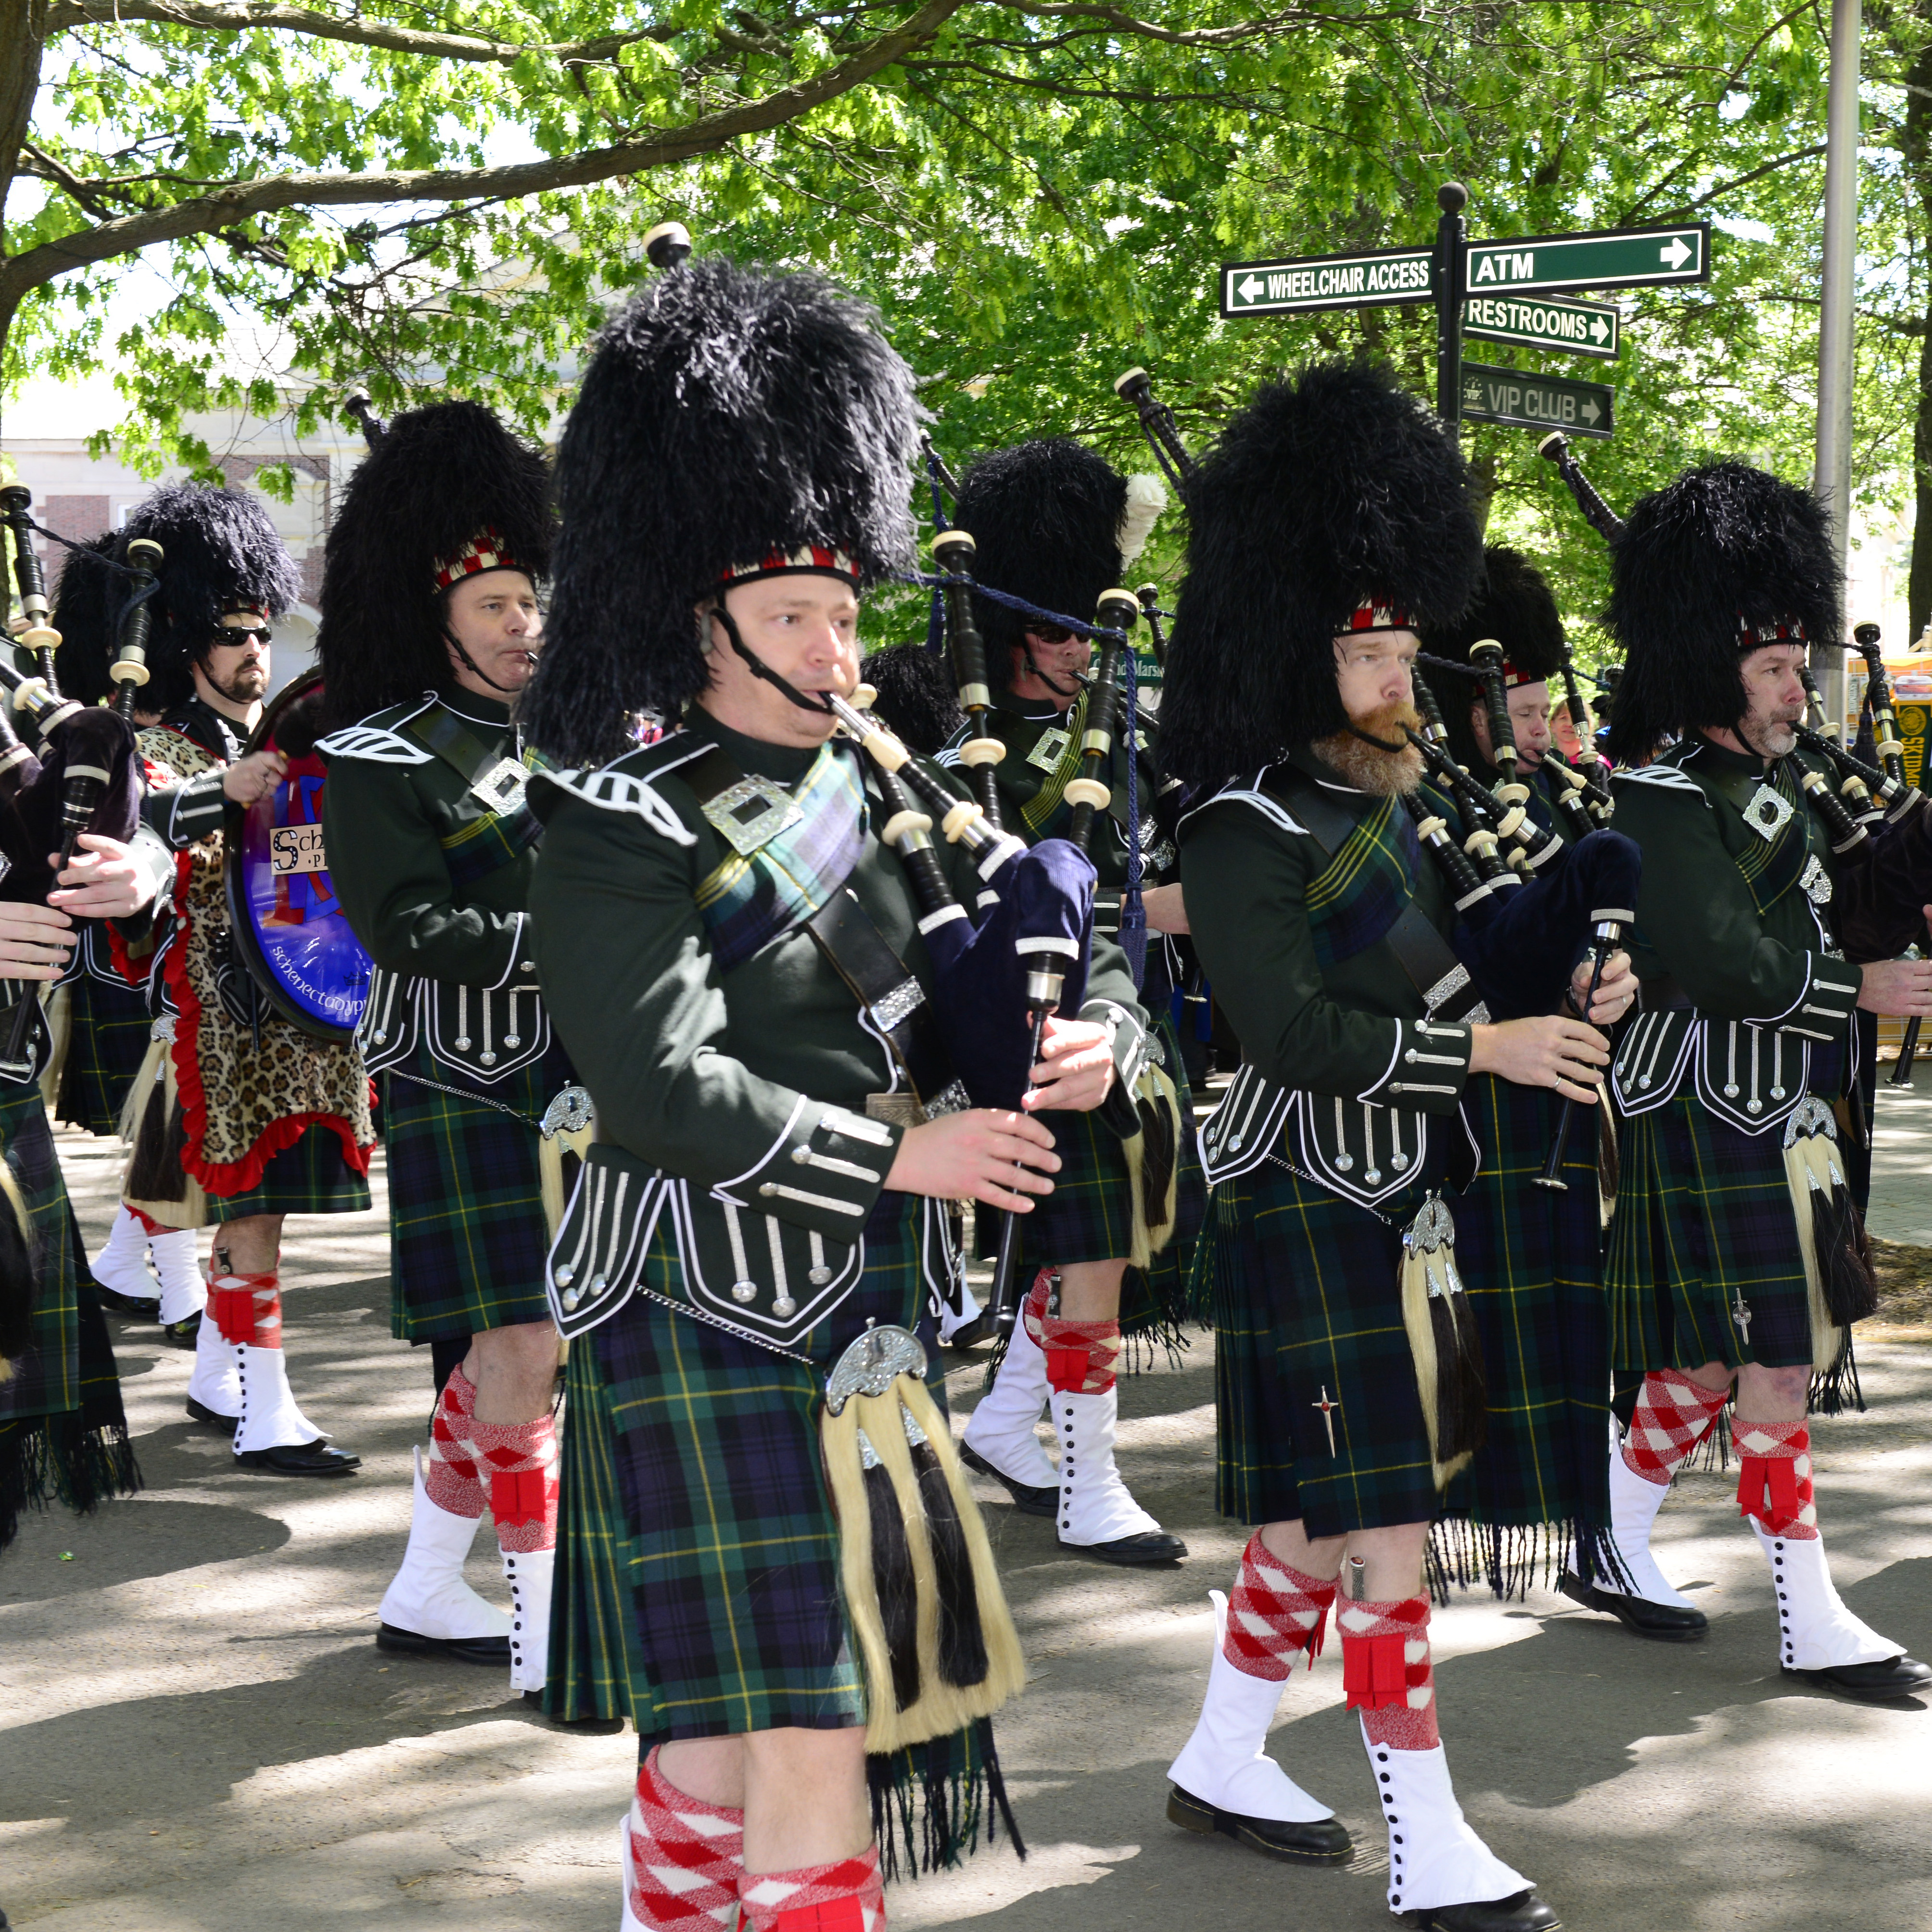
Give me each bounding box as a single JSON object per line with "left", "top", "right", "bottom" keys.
{"left": 124, "top": 483, "right": 375, "bottom": 1476}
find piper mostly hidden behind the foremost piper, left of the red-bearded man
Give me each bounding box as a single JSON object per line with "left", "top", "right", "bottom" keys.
{"left": 943, "top": 437, "right": 1206, "bottom": 1565}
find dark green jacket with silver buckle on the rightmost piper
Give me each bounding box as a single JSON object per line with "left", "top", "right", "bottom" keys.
{"left": 1611, "top": 736, "right": 1862, "bottom": 1134}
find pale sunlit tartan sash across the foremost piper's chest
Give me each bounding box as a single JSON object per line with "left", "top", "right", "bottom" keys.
{"left": 698, "top": 740, "right": 865, "bottom": 974}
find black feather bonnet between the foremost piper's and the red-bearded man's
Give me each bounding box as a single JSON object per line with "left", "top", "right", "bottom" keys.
{"left": 953, "top": 437, "right": 1126, "bottom": 690}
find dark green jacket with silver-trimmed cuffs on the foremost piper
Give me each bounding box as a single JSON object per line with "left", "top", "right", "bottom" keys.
{"left": 529, "top": 707, "right": 1145, "bottom": 1345}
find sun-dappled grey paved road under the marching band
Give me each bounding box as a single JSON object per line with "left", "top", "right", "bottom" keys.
{"left": 0, "top": 1097, "right": 1932, "bottom": 1932}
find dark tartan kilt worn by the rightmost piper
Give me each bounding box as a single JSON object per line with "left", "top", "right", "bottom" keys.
{"left": 1603, "top": 1082, "right": 1812, "bottom": 1373}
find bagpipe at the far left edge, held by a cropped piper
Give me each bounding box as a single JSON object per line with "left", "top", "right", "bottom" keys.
{"left": 0, "top": 483, "right": 144, "bottom": 1082}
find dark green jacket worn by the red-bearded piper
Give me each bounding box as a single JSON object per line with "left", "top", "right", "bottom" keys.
{"left": 1181, "top": 750, "right": 1472, "bottom": 1206}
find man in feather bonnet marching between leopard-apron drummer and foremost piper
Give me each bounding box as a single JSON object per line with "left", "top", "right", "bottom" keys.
{"left": 317, "top": 402, "right": 564, "bottom": 1694}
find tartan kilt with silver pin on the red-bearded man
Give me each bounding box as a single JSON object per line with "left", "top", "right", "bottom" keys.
{"left": 1202, "top": 1159, "right": 1461, "bottom": 1538}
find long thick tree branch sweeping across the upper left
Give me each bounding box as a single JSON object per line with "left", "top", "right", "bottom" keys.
{"left": 0, "top": 0, "right": 964, "bottom": 317}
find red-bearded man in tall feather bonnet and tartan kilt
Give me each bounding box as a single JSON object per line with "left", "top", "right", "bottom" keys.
{"left": 1161, "top": 363, "right": 1617, "bottom": 1932}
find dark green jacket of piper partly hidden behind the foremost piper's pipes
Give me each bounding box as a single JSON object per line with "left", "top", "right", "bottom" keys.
{"left": 939, "top": 690, "right": 1179, "bottom": 933}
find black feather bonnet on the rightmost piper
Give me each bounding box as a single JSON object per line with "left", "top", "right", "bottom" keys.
{"left": 1603, "top": 462, "right": 1841, "bottom": 763}
